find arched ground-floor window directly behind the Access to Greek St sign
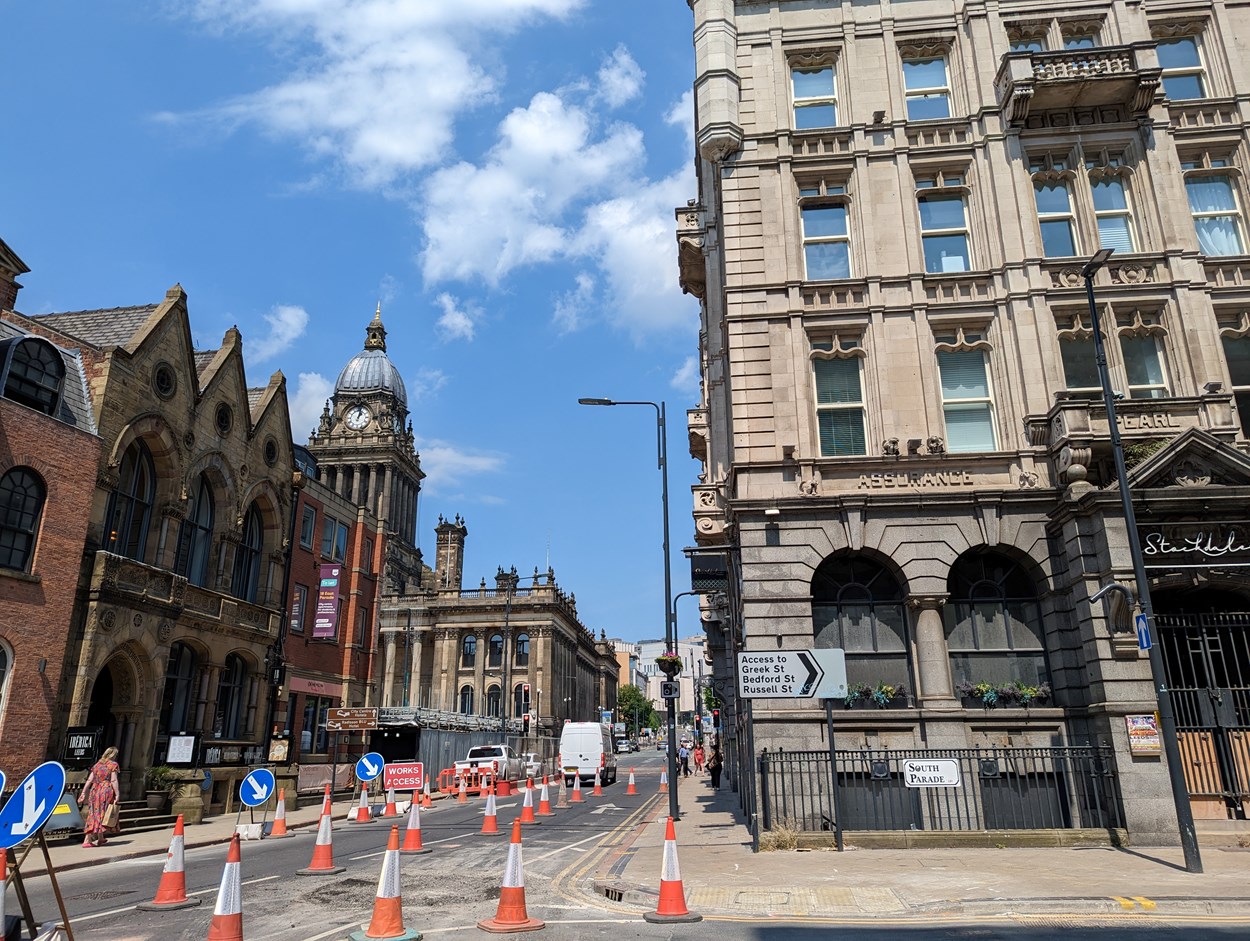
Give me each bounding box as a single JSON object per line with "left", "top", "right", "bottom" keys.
{"left": 811, "top": 556, "right": 915, "bottom": 689}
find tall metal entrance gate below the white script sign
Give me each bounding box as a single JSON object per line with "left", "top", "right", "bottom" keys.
{"left": 1155, "top": 612, "right": 1250, "bottom": 820}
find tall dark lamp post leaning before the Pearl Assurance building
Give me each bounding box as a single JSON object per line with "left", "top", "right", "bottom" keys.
{"left": 1081, "top": 249, "right": 1203, "bottom": 872}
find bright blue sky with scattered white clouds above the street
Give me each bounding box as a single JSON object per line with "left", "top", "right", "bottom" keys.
{"left": 7, "top": 0, "right": 699, "bottom": 639}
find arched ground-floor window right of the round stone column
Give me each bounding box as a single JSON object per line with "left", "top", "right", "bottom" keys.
{"left": 944, "top": 550, "right": 1049, "bottom": 686}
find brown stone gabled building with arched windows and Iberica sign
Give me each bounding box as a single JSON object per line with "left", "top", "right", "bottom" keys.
{"left": 4, "top": 277, "right": 293, "bottom": 819}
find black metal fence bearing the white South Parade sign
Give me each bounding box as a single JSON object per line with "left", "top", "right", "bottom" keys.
{"left": 759, "top": 745, "right": 1123, "bottom": 831}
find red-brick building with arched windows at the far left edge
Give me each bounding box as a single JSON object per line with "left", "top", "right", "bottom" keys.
{"left": 0, "top": 241, "right": 100, "bottom": 786}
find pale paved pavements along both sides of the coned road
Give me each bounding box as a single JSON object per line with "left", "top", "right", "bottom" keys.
{"left": 19, "top": 775, "right": 1250, "bottom": 924}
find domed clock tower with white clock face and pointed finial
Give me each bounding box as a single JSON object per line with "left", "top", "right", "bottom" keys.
{"left": 309, "top": 304, "right": 425, "bottom": 594}
